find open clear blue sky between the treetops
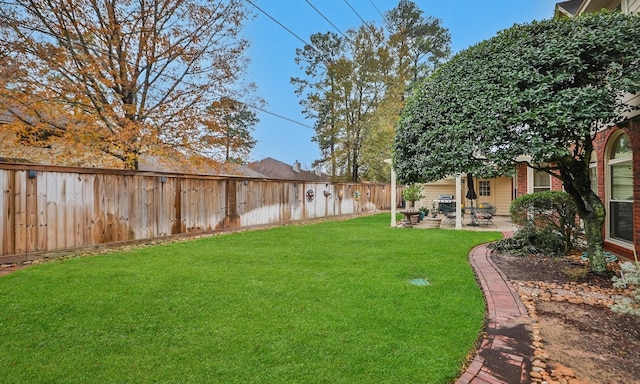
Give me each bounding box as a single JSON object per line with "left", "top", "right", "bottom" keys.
{"left": 244, "top": 0, "right": 559, "bottom": 169}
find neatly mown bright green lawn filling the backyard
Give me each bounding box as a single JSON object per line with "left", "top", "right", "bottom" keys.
{"left": 0, "top": 214, "right": 500, "bottom": 384}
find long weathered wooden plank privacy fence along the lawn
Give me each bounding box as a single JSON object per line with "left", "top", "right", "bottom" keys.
{"left": 0, "top": 163, "right": 400, "bottom": 263}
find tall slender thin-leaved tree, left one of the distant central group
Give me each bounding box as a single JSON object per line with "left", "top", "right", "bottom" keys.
{"left": 291, "top": 25, "right": 391, "bottom": 181}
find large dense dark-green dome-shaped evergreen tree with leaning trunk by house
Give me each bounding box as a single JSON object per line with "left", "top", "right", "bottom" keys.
{"left": 394, "top": 13, "right": 640, "bottom": 273}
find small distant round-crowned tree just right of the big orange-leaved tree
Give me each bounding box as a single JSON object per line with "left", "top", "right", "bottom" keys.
{"left": 202, "top": 97, "right": 259, "bottom": 163}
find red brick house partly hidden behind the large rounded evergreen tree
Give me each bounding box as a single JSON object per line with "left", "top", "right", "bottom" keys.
{"left": 514, "top": 0, "right": 640, "bottom": 258}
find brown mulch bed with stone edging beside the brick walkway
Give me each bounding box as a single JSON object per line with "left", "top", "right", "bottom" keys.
{"left": 491, "top": 252, "right": 640, "bottom": 384}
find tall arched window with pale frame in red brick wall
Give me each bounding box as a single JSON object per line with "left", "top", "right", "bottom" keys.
{"left": 608, "top": 133, "right": 633, "bottom": 242}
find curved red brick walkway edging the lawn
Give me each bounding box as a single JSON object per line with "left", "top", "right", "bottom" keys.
{"left": 456, "top": 243, "right": 533, "bottom": 384}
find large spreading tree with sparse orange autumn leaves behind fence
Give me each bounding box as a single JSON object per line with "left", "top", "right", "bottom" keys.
{"left": 0, "top": 0, "right": 255, "bottom": 168}
